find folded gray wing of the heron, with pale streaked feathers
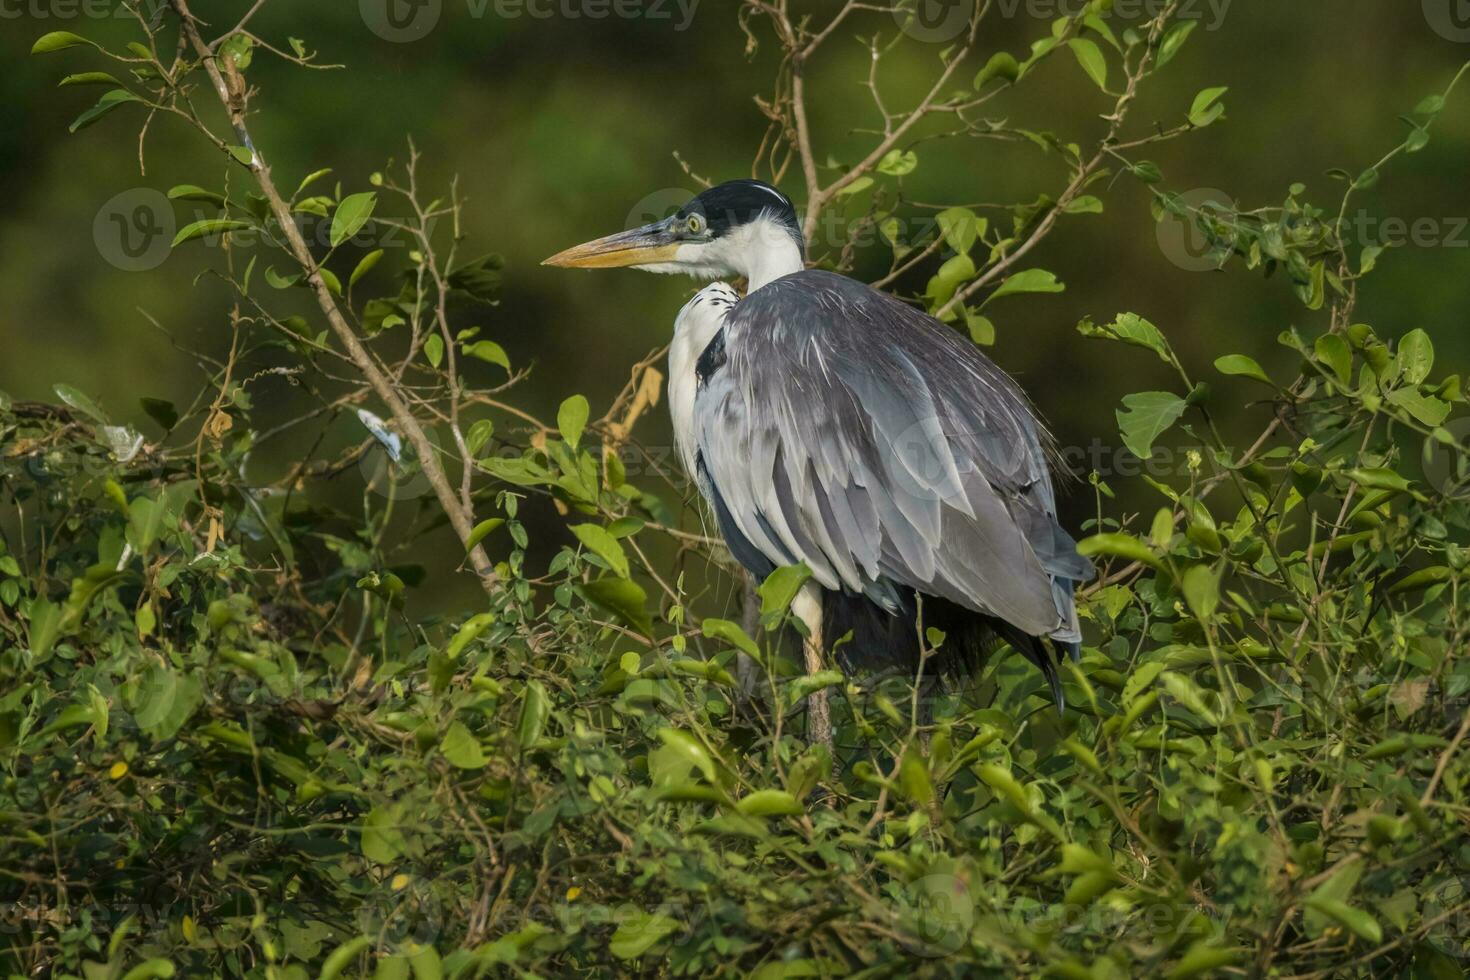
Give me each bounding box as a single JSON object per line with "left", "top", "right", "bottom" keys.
{"left": 694, "top": 270, "right": 1092, "bottom": 639}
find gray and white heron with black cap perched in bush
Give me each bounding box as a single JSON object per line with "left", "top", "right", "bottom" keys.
{"left": 545, "top": 179, "right": 1094, "bottom": 742}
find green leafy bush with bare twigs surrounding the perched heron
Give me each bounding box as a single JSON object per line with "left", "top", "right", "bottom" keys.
{"left": 0, "top": 1, "right": 1470, "bottom": 980}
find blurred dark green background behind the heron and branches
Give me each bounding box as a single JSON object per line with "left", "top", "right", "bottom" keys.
{"left": 0, "top": 0, "right": 1470, "bottom": 590}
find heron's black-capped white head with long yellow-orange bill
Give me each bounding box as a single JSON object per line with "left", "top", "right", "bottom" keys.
{"left": 544, "top": 181, "right": 804, "bottom": 289}
